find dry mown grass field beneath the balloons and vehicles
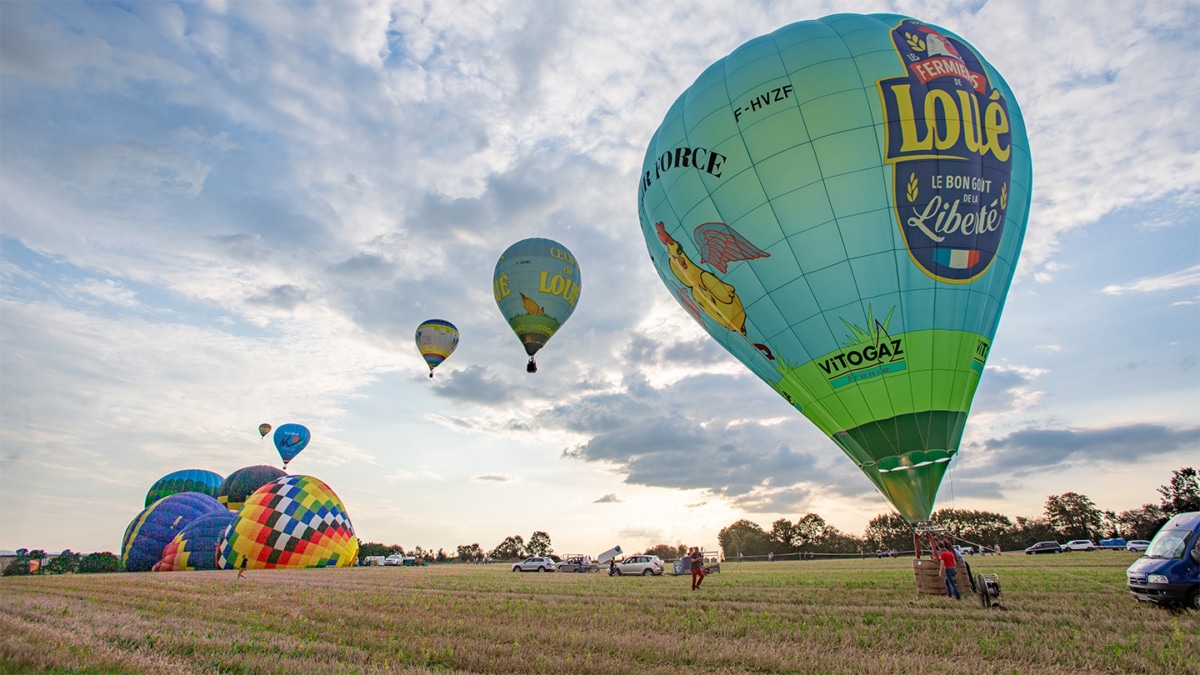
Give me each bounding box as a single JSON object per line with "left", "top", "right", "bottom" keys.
{"left": 0, "top": 551, "right": 1200, "bottom": 675}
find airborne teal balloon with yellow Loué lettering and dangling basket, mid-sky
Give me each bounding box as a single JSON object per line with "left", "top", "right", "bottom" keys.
{"left": 492, "top": 238, "right": 583, "bottom": 372}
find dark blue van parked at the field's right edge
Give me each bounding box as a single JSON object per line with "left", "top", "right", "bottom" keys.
{"left": 1126, "top": 512, "right": 1200, "bottom": 610}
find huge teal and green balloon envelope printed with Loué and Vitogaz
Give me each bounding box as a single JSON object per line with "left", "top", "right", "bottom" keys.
{"left": 638, "top": 14, "right": 1032, "bottom": 522}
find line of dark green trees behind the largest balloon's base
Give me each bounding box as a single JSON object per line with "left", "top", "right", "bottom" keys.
{"left": 718, "top": 467, "right": 1200, "bottom": 558}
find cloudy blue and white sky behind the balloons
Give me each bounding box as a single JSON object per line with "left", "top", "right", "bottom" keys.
{"left": 0, "top": 0, "right": 1200, "bottom": 554}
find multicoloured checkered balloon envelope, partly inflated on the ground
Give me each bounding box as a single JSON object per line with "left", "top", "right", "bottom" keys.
{"left": 217, "top": 476, "right": 359, "bottom": 569}
